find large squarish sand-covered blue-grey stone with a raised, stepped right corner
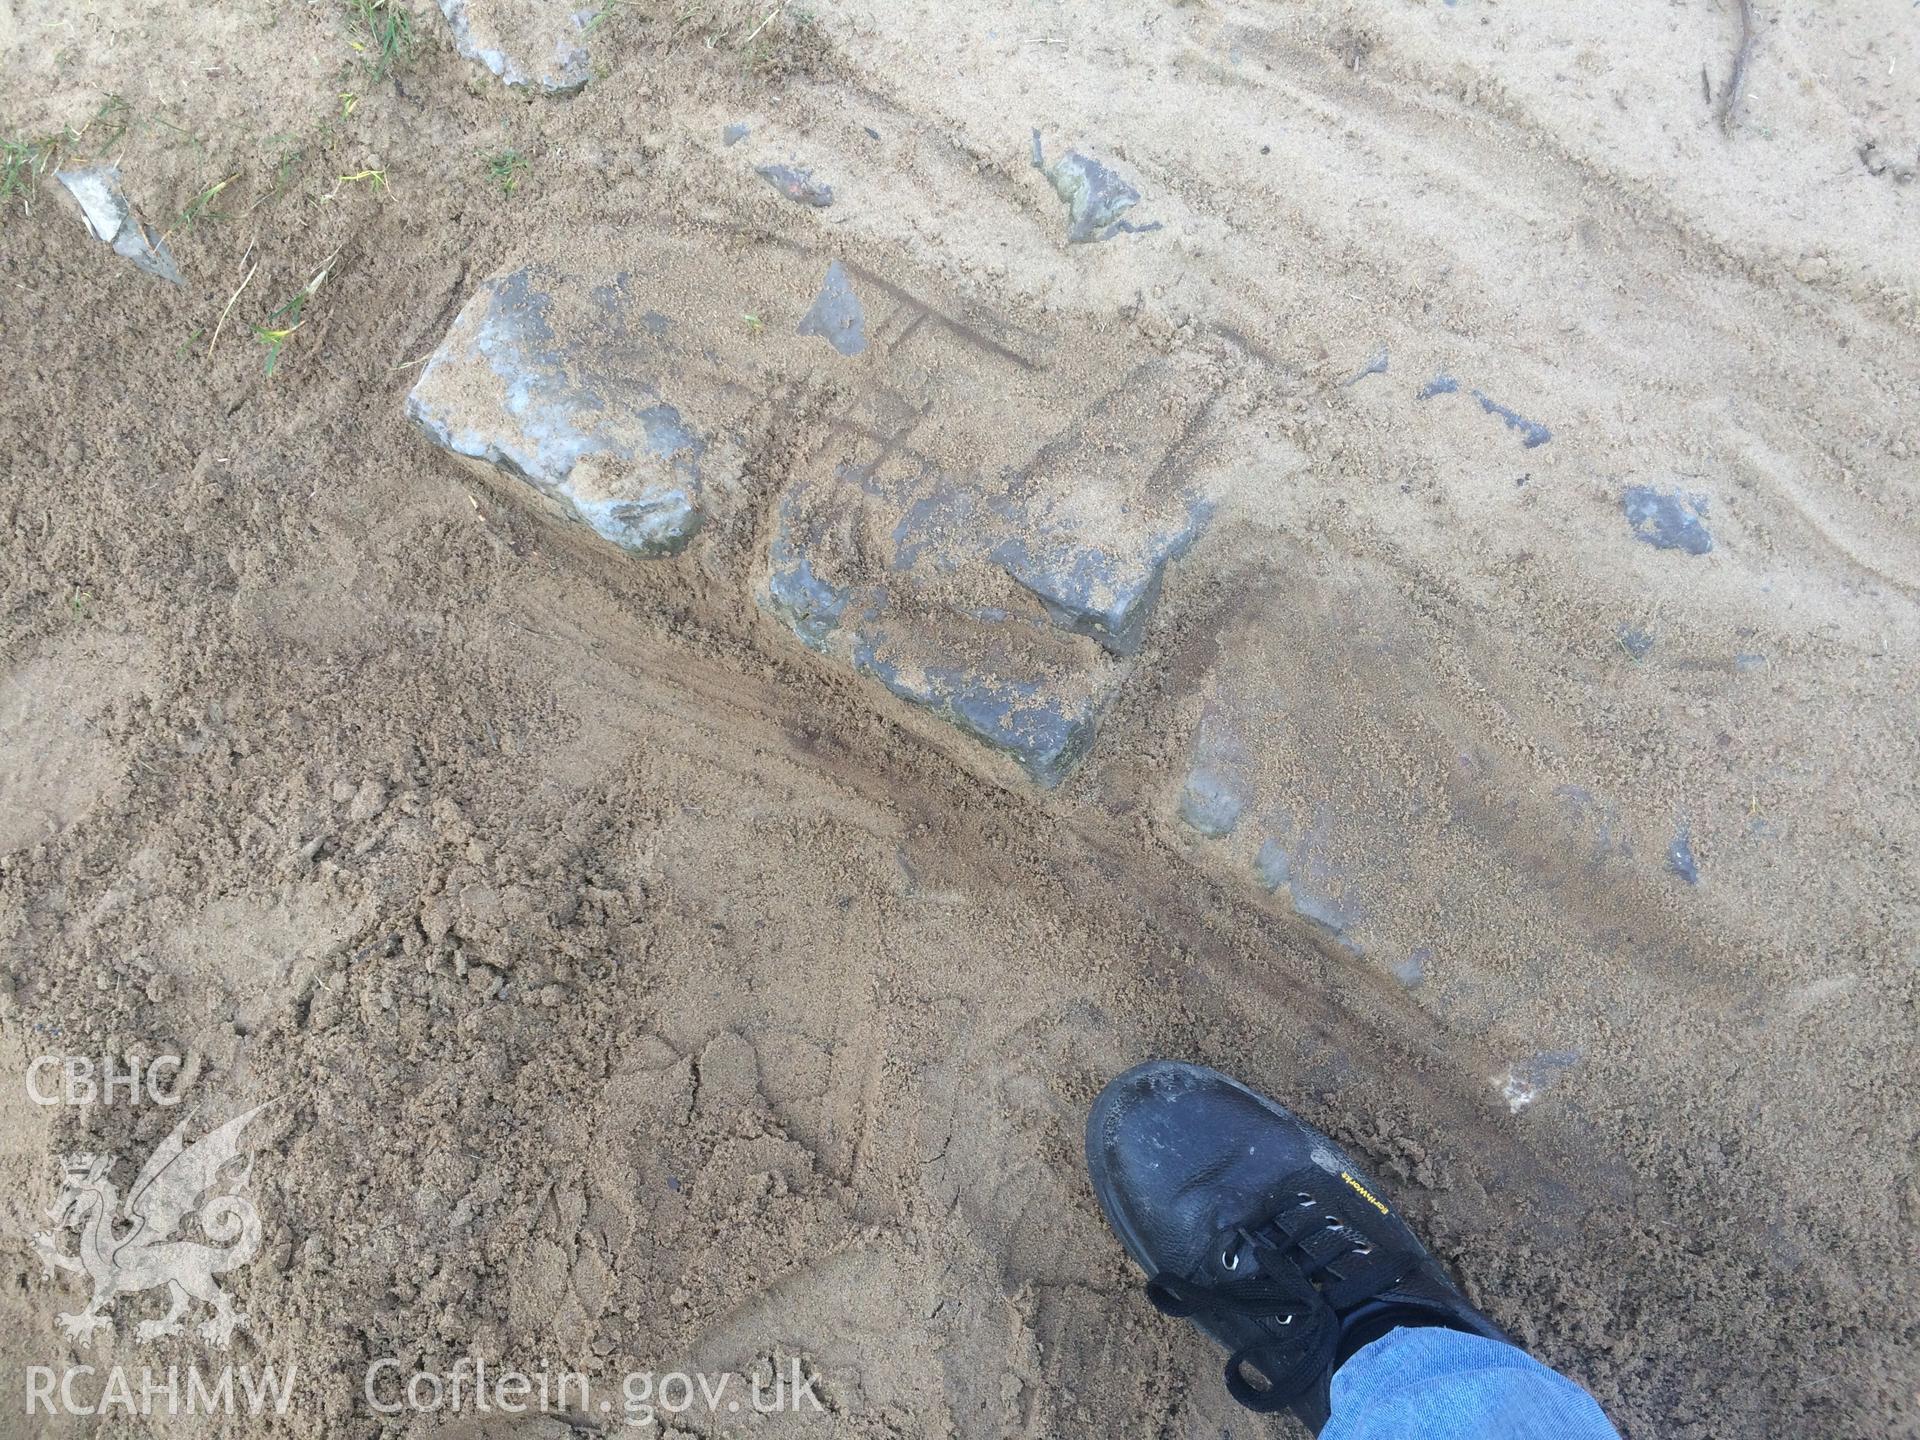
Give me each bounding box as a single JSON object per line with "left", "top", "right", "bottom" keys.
{"left": 762, "top": 303, "right": 1236, "bottom": 785}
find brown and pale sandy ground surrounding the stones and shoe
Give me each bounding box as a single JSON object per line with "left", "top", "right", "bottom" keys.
{"left": 0, "top": 0, "right": 1920, "bottom": 1438}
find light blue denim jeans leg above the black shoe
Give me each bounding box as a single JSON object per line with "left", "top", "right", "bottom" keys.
{"left": 1321, "top": 1325, "right": 1620, "bottom": 1440}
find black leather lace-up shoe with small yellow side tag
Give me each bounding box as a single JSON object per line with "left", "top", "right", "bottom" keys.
{"left": 1087, "top": 1060, "right": 1507, "bottom": 1434}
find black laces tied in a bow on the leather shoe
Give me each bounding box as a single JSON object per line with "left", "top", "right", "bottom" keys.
{"left": 1146, "top": 1171, "right": 1419, "bottom": 1411}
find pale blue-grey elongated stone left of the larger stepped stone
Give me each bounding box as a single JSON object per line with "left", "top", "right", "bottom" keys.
{"left": 407, "top": 269, "right": 707, "bottom": 555}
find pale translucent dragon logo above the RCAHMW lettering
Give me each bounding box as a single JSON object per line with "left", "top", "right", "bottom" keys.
{"left": 33, "top": 1100, "right": 273, "bottom": 1350}
